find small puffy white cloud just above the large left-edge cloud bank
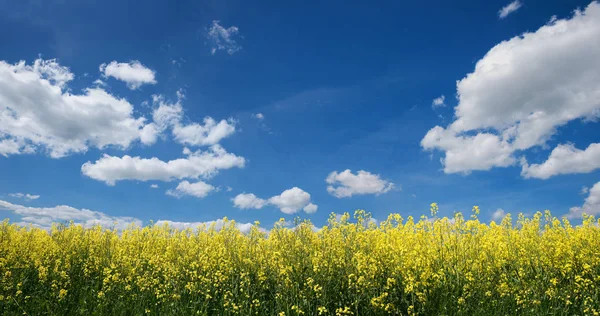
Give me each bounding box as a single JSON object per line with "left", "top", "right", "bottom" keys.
{"left": 100, "top": 60, "right": 156, "bottom": 90}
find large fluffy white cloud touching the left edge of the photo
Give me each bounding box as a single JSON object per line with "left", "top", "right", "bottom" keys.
{"left": 0, "top": 59, "right": 157, "bottom": 158}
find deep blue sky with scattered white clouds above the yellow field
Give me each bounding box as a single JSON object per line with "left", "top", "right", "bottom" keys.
{"left": 0, "top": 0, "right": 600, "bottom": 227}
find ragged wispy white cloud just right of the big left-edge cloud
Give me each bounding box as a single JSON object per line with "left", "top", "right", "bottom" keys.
{"left": 149, "top": 91, "right": 236, "bottom": 146}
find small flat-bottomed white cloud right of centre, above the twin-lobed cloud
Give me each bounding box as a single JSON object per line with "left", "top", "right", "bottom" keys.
{"left": 325, "top": 169, "right": 394, "bottom": 198}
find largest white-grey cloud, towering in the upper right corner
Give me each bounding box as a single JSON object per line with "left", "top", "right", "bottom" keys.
{"left": 421, "top": 2, "right": 600, "bottom": 173}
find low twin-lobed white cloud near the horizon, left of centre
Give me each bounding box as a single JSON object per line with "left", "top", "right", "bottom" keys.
{"left": 232, "top": 187, "right": 318, "bottom": 214}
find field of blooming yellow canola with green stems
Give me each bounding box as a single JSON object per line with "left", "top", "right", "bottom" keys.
{"left": 0, "top": 204, "right": 600, "bottom": 315}
